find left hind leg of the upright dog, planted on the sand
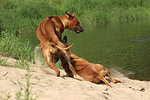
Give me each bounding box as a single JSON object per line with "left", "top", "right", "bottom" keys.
{"left": 42, "top": 47, "right": 60, "bottom": 77}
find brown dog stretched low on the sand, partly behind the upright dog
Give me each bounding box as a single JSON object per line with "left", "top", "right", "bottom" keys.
{"left": 60, "top": 36, "right": 121, "bottom": 87}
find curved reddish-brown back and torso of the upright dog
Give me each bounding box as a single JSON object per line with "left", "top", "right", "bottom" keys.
{"left": 36, "top": 17, "right": 64, "bottom": 47}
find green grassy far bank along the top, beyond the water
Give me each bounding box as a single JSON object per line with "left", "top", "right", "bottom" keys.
{"left": 0, "top": 0, "right": 150, "bottom": 33}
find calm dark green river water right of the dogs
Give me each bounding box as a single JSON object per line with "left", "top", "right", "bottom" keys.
{"left": 24, "top": 20, "right": 150, "bottom": 80}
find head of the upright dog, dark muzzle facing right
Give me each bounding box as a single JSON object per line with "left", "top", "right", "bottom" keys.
{"left": 65, "top": 12, "right": 84, "bottom": 34}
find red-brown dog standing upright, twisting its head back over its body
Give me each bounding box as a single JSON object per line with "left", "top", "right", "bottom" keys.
{"left": 36, "top": 12, "right": 84, "bottom": 76}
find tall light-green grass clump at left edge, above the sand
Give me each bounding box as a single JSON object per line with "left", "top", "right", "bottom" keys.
{"left": 0, "top": 32, "right": 34, "bottom": 62}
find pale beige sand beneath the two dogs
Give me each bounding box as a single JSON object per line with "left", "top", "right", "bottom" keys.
{"left": 0, "top": 66, "right": 150, "bottom": 100}
